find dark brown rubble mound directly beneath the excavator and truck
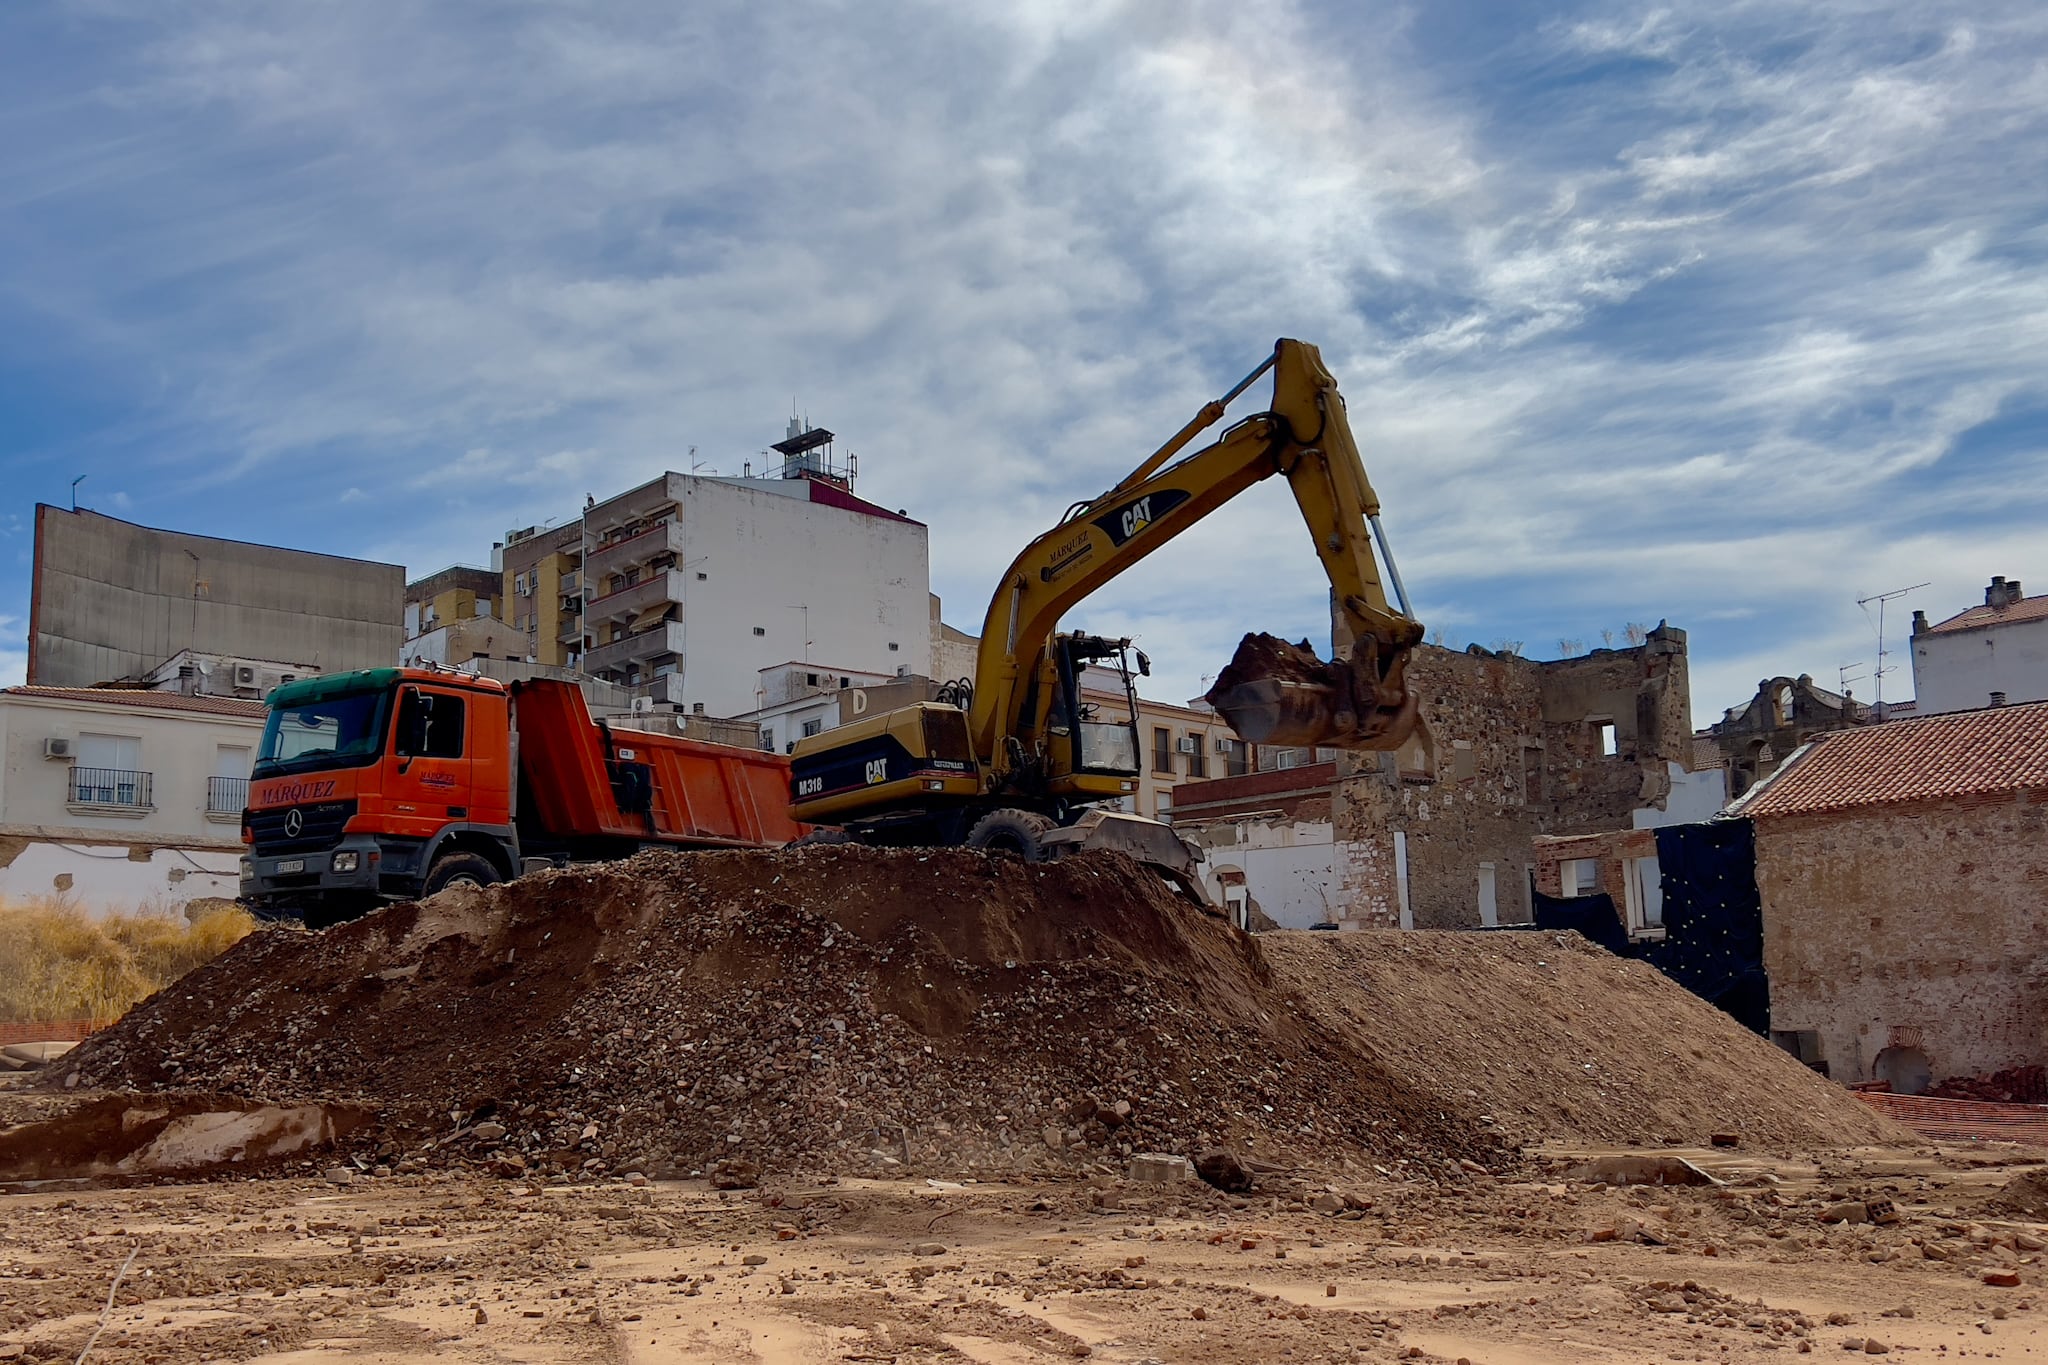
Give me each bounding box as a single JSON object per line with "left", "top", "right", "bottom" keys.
{"left": 66, "top": 847, "right": 1499, "bottom": 1183}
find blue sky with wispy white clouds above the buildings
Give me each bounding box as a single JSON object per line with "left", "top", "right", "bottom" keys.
{"left": 0, "top": 0, "right": 2048, "bottom": 722}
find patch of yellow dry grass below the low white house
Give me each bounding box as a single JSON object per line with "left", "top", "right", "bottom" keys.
{"left": 0, "top": 898, "right": 256, "bottom": 1023}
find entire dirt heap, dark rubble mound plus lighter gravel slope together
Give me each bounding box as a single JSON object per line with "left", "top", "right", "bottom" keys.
{"left": 53, "top": 847, "right": 1896, "bottom": 1173}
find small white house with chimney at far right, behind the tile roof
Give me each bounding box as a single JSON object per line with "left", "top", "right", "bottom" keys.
{"left": 1913, "top": 575, "right": 2048, "bottom": 716}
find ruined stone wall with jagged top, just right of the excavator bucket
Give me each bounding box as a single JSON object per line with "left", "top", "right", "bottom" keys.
{"left": 1331, "top": 626, "right": 1692, "bottom": 929}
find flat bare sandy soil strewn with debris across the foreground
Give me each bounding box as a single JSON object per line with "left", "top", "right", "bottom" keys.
{"left": 0, "top": 1148, "right": 2048, "bottom": 1365}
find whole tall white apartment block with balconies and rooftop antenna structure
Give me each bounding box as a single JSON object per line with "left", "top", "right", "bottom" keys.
{"left": 580, "top": 430, "right": 932, "bottom": 716}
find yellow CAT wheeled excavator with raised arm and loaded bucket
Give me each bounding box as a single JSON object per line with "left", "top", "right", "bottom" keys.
{"left": 791, "top": 338, "right": 1421, "bottom": 866}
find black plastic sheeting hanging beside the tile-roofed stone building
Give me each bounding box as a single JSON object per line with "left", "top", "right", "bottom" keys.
{"left": 1534, "top": 821, "right": 1772, "bottom": 1038}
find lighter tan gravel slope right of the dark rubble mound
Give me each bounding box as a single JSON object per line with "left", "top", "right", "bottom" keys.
{"left": 1260, "top": 931, "right": 1915, "bottom": 1150}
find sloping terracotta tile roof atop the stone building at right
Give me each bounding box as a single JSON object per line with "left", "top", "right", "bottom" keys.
{"left": 1731, "top": 702, "right": 2048, "bottom": 817}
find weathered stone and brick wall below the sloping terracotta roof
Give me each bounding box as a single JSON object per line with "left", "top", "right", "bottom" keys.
{"left": 1757, "top": 790, "right": 2048, "bottom": 1083}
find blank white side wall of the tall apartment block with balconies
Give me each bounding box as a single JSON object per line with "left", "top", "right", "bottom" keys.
{"left": 622, "top": 475, "right": 932, "bottom": 716}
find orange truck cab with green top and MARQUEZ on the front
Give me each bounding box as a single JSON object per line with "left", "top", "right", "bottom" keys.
{"left": 242, "top": 669, "right": 518, "bottom": 923}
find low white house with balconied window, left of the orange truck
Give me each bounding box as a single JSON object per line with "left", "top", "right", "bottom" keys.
{"left": 0, "top": 688, "right": 264, "bottom": 913}
